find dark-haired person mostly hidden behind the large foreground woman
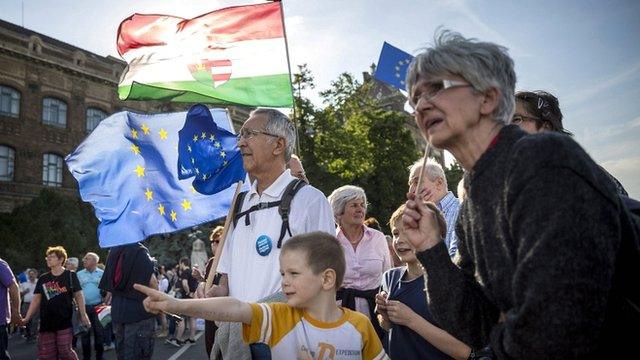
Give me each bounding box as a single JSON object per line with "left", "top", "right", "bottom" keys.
{"left": 511, "top": 90, "right": 629, "bottom": 196}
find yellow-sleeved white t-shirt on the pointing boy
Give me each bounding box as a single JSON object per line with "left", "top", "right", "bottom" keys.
{"left": 242, "top": 303, "right": 388, "bottom": 360}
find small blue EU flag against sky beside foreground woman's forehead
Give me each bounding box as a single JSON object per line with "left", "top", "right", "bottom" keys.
{"left": 373, "top": 41, "right": 413, "bottom": 90}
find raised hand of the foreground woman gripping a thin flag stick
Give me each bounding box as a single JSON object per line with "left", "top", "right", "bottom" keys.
{"left": 402, "top": 193, "right": 442, "bottom": 251}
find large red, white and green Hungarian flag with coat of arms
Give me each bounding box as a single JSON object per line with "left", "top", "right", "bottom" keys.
{"left": 118, "top": 2, "right": 293, "bottom": 107}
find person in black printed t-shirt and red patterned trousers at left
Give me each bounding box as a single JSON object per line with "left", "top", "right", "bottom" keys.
{"left": 22, "top": 246, "right": 91, "bottom": 359}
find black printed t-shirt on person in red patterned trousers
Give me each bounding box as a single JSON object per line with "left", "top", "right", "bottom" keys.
{"left": 33, "top": 270, "right": 82, "bottom": 332}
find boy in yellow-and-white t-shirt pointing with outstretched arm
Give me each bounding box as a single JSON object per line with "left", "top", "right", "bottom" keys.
{"left": 135, "top": 232, "right": 388, "bottom": 360}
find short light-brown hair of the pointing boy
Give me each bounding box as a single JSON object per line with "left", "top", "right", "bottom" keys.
{"left": 280, "top": 231, "right": 347, "bottom": 290}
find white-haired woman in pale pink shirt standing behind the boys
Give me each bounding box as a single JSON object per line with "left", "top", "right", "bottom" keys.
{"left": 329, "top": 185, "right": 391, "bottom": 336}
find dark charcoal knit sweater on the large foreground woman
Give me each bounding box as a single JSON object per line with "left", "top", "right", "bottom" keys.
{"left": 417, "top": 125, "right": 637, "bottom": 359}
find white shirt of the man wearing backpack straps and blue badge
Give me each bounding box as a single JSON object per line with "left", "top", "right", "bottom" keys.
{"left": 218, "top": 170, "right": 335, "bottom": 302}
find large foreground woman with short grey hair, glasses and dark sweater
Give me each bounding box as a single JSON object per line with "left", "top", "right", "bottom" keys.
{"left": 403, "top": 31, "right": 638, "bottom": 359}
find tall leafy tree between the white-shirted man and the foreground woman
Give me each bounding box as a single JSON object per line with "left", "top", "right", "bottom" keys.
{"left": 294, "top": 65, "right": 419, "bottom": 229}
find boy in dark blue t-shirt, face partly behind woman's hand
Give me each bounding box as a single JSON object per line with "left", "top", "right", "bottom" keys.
{"left": 376, "top": 203, "right": 471, "bottom": 359}
